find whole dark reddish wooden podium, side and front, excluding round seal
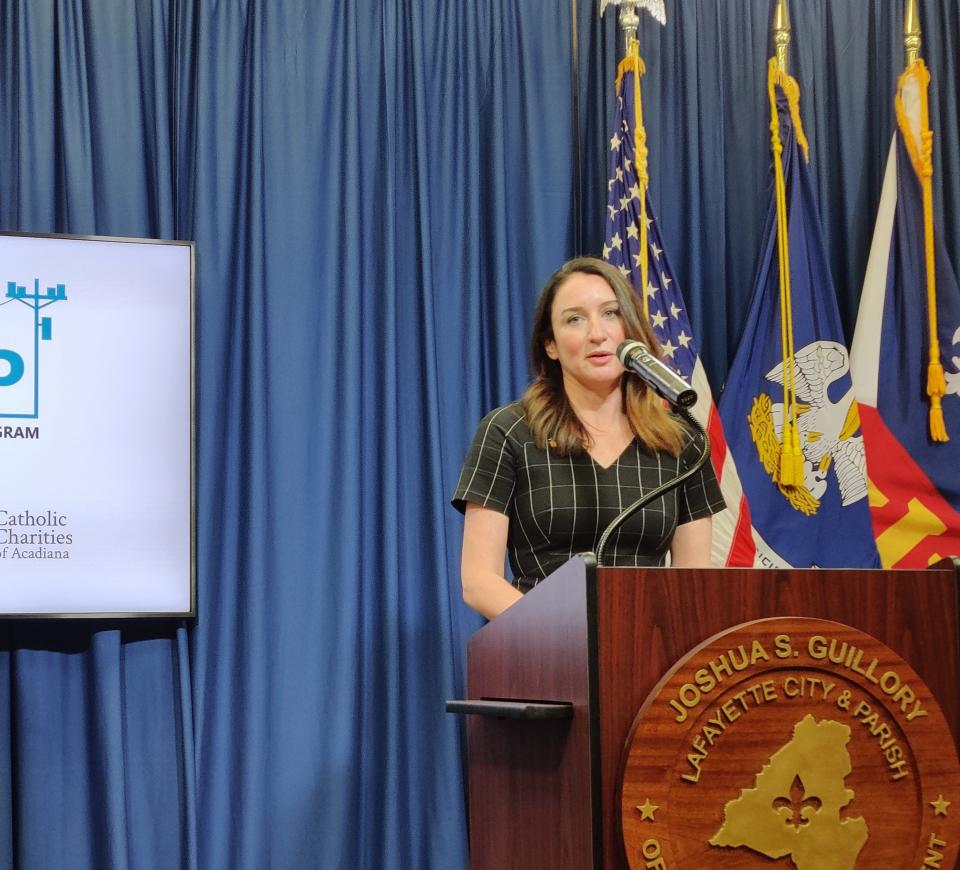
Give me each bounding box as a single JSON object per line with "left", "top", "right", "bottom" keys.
{"left": 448, "top": 557, "right": 960, "bottom": 870}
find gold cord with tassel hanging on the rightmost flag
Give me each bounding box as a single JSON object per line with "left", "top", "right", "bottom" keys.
{"left": 896, "top": 57, "right": 950, "bottom": 442}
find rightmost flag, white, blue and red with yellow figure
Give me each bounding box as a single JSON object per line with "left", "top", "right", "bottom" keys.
{"left": 852, "top": 60, "right": 960, "bottom": 568}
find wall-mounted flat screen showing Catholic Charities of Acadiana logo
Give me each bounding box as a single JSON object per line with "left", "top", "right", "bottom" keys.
{"left": 0, "top": 233, "right": 196, "bottom": 618}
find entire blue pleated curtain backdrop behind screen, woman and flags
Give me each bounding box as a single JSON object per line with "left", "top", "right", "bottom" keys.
{"left": 0, "top": 0, "right": 960, "bottom": 870}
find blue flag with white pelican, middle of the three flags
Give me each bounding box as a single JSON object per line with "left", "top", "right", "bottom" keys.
{"left": 720, "top": 59, "right": 879, "bottom": 568}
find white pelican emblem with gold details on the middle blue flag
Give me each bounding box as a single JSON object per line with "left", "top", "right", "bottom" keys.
{"left": 748, "top": 341, "right": 867, "bottom": 516}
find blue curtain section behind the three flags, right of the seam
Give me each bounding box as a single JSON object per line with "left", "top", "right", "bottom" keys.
{"left": 579, "top": 0, "right": 960, "bottom": 391}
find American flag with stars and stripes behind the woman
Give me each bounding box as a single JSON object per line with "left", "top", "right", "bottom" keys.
{"left": 603, "top": 52, "right": 756, "bottom": 566}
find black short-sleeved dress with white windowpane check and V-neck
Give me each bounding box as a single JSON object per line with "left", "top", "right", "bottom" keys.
{"left": 452, "top": 402, "right": 724, "bottom": 592}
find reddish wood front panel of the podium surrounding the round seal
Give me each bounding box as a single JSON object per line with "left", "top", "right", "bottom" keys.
{"left": 597, "top": 568, "right": 960, "bottom": 870}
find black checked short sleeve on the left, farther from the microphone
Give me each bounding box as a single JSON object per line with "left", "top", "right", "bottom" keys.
{"left": 451, "top": 404, "right": 523, "bottom": 514}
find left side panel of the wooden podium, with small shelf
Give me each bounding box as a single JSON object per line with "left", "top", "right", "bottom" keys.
{"left": 467, "top": 560, "right": 599, "bottom": 870}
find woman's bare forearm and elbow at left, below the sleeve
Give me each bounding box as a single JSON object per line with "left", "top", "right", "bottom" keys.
{"left": 460, "top": 503, "right": 523, "bottom": 619}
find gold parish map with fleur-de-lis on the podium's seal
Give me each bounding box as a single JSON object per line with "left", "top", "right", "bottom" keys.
{"left": 710, "top": 713, "right": 868, "bottom": 870}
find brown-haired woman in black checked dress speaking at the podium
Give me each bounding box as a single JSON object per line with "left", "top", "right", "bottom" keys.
{"left": 453, "top": 257, "right": 724, "bottom": 618}
